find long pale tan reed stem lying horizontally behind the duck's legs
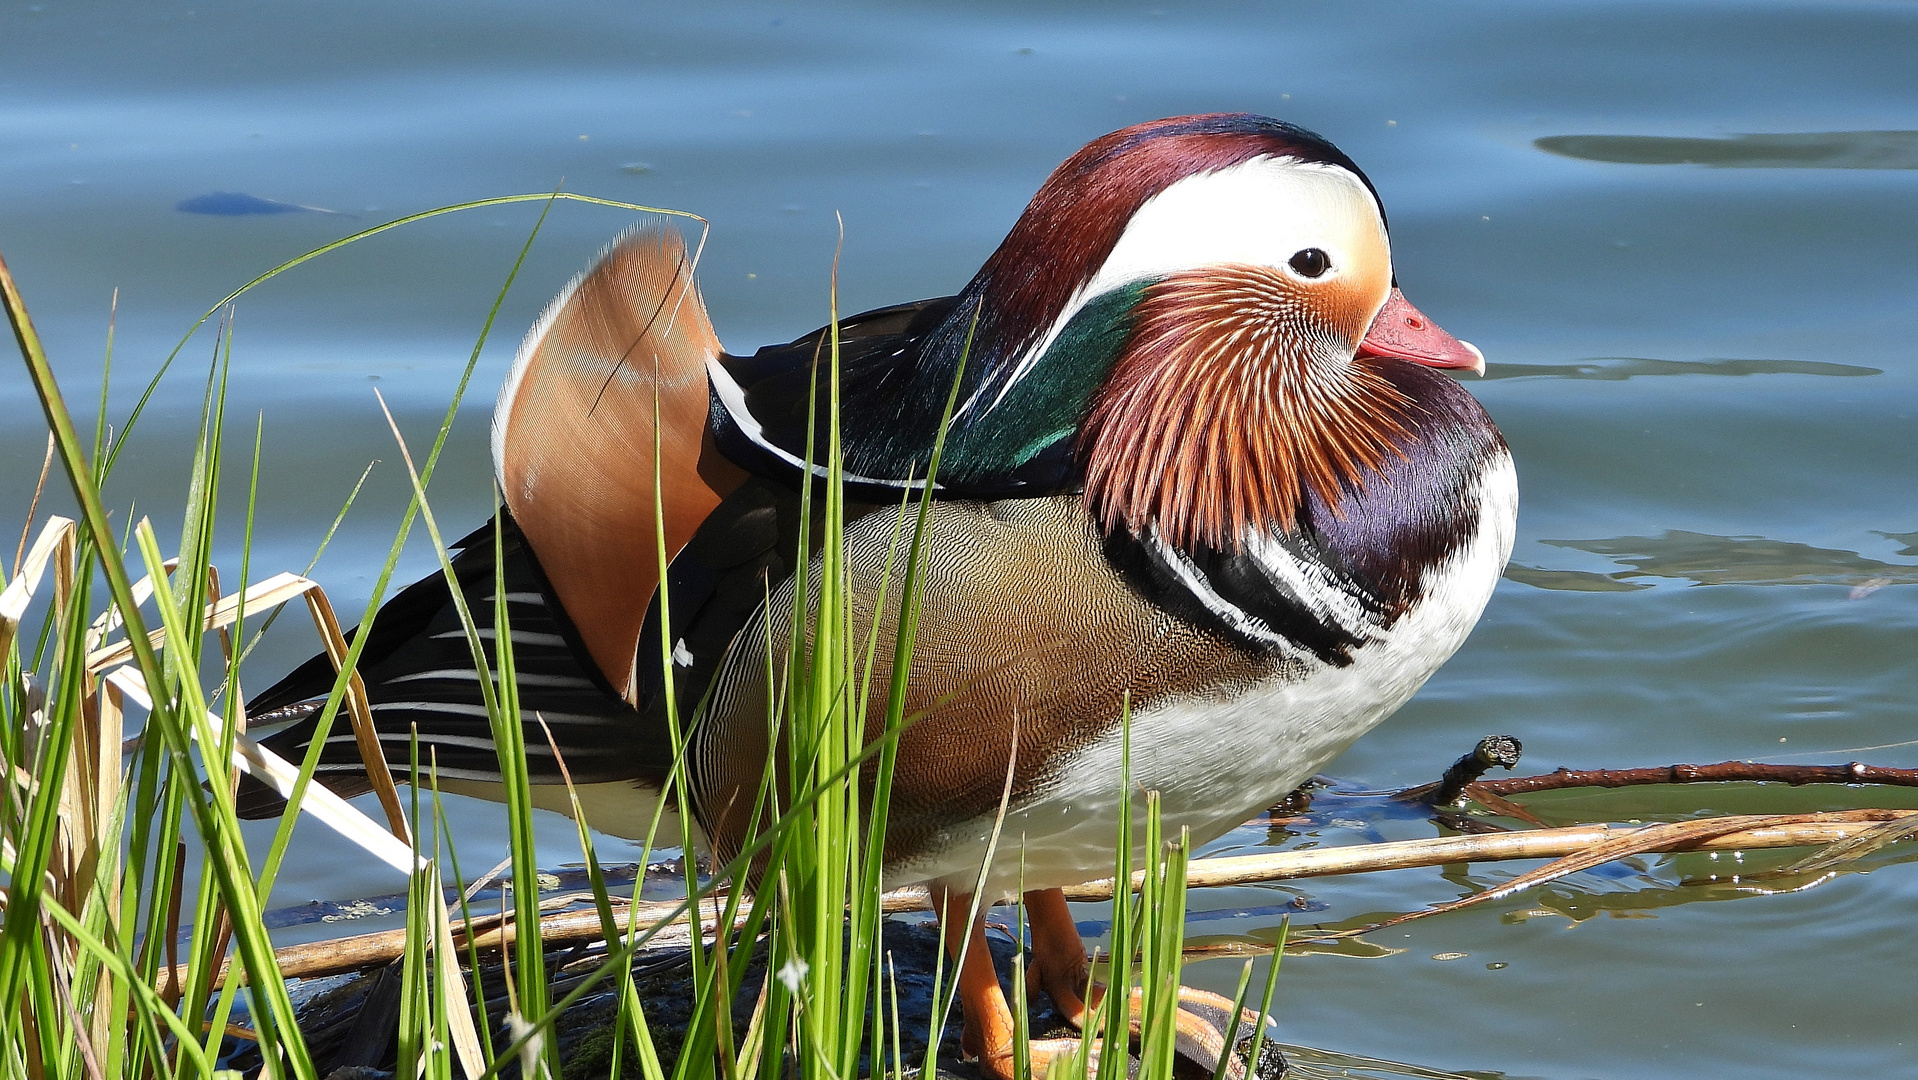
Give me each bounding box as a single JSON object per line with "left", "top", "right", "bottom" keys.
{"left": 161, "top": 810, "right": 1918, "bottom": 986}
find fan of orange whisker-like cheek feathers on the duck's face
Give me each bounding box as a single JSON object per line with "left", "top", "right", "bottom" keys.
{"left": 1082, "top": 267, "right": 1404, "bottom": 549}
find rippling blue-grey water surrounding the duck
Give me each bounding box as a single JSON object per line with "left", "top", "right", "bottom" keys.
{"left": 0, "top": 0, "right": 1918, "bottom": 1080}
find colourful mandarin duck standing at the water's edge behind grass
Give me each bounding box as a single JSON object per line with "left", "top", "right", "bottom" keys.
{"left": 242, "top": 113, "right": 1517, "bottom": 1078}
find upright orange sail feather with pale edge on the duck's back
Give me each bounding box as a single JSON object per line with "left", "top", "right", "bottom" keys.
{"left": 493, "top": 226, "right": 744, "bottom": 700}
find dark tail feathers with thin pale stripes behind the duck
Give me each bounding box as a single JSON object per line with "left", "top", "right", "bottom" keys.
{"left": 238, "top": 514, "right": 671, "bottom": 817}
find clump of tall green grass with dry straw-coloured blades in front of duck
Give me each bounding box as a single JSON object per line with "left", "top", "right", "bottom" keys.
{"left": 0, "top": 196, "right": 1275, "bottom": 1080}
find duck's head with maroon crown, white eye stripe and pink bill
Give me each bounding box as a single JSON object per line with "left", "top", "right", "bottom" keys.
{"left": 943, "top": 113, "right": 1485, "bottom": 547}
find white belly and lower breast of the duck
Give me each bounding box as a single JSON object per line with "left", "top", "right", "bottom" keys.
{"left": 886, "top": 455, "right": 1517, "bottom": 896}
